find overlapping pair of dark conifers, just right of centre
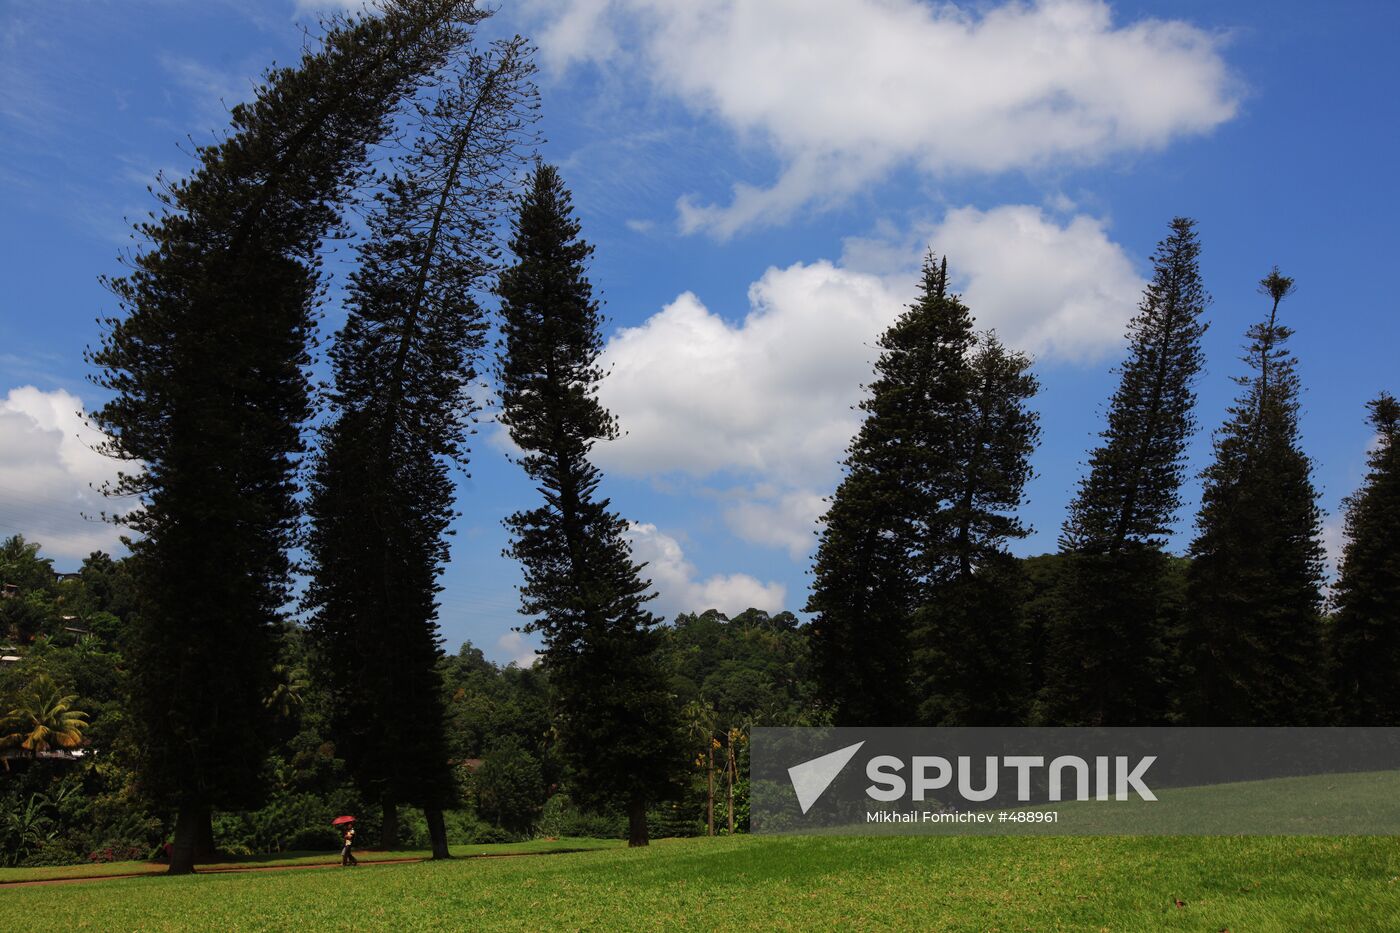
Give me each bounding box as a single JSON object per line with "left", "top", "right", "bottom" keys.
{"left": 808, "top": 256, "right": 1036, "bottom": 726}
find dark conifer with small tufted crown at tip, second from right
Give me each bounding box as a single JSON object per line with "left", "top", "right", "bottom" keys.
{"left": 1180, "top": 269, "right": 1329, "bottom": 726}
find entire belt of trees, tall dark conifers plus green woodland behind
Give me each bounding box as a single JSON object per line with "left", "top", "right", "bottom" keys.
{"left": 0, "top": 0, "right": 1400, "bottom": 873}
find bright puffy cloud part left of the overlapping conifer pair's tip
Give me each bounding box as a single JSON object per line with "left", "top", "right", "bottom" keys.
{"left": 598, "top": 261, "right": 900, "bottom": 483}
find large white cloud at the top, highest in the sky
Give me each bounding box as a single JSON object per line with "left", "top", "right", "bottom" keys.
{"left": 533, "top": 0, "right": 1236, "bottom": 238}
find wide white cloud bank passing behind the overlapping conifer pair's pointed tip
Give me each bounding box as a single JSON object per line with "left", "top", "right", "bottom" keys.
{"left": 598, "top": 205, "right": 1144, "bottom": 559}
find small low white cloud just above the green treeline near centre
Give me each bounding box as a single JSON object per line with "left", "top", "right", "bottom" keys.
{"left": 627, "top": 523, "right": 787, "bottom": 618}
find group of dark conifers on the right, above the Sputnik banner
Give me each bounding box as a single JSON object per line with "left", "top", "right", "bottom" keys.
{"left": 806, "top": 219, "right": 1400, "bottom": 726}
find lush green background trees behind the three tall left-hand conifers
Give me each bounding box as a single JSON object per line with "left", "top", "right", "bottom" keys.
{"left": 0, "top": 537, "right": 820, "bottom": 866}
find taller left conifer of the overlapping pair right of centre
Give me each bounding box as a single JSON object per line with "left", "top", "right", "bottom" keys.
{"left": 806, "top": 255, "right": 976, "bottom": 726}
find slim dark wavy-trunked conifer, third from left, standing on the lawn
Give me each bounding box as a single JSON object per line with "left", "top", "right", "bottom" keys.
{"left": 497, "top": 165, "right": 685, "bottom": 846}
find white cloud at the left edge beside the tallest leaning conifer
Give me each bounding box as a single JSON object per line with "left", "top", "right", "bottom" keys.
{"left": 0, "top": 385, "right": 120, "bottom": 559}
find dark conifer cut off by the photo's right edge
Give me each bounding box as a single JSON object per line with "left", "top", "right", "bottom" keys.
{"left": 1330, "top": 392, "right": 1400, "bottom": 726}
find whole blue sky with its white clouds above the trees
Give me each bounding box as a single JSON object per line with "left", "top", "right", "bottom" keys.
{"left": 0, "top": 0, "right": 1400, "bottom": 661}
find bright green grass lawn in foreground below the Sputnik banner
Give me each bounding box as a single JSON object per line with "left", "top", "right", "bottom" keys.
{"left": 0, "top": 836, "right": 1400, "bottom": 933}
